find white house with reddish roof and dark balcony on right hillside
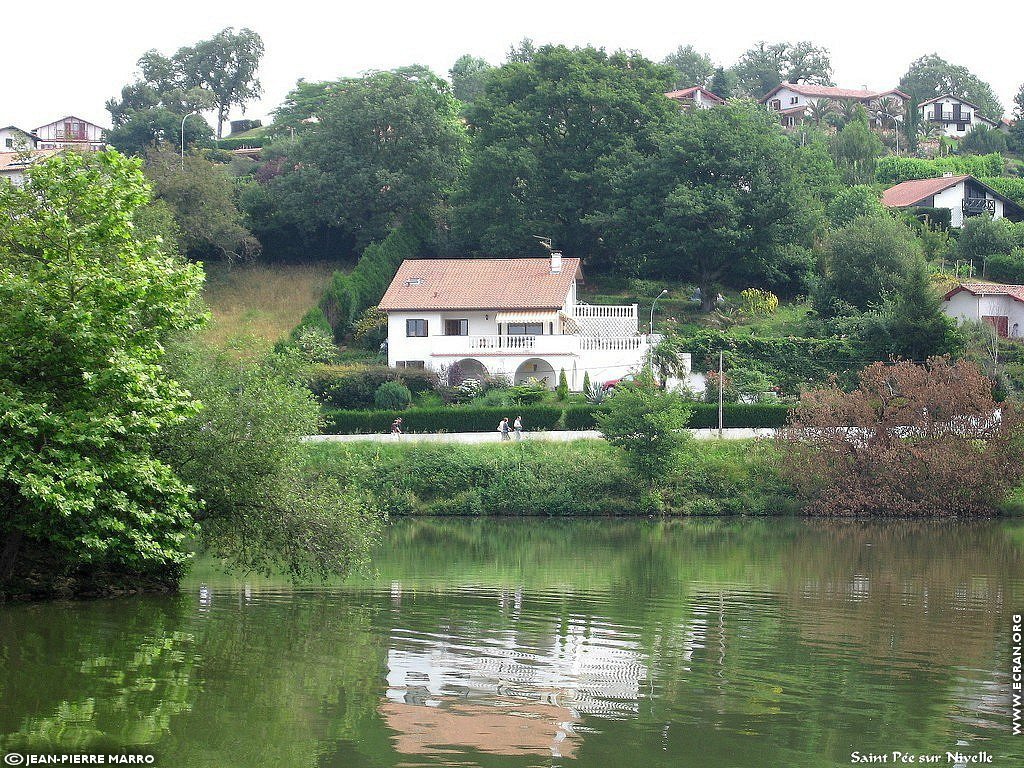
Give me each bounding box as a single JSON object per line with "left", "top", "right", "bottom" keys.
{"left": 882, "top": 173, "right": 1024, "bottom": 228}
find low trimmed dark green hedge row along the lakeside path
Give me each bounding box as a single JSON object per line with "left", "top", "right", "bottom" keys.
{"left": 324, "top": 402, "right": 790, "bottom": 434}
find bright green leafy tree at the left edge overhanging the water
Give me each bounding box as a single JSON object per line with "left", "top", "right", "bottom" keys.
{"left": 0, "top": 152, "right": 203, "bottom": 588}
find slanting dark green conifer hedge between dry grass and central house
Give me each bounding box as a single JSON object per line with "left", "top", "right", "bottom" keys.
{"left": 321, "top": 227, "right": 420, "bottom": 338}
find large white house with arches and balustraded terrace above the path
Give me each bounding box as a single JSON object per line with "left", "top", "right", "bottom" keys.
{"left": 380, "top": 253, "right": 658, "bottom": 391}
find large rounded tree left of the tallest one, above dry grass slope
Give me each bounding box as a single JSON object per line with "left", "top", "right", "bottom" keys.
{"left": 258, "top": 69, "right": 466, "bottom": 249}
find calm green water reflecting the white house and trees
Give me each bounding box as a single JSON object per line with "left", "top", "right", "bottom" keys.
{"left": 0, "top": 520, "right": 1024, "bottom": 768}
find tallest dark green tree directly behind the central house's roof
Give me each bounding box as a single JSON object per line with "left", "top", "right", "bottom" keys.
{"left": 455, "top": 46, "right": 678, "bottom": 267}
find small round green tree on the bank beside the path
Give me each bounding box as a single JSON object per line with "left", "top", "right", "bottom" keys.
{"left": 597, "top": 375, "right": 692, "bottom": 484}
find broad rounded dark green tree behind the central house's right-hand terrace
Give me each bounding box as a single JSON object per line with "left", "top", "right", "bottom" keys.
{"left": 589, "top": 101, "right": 815, "bottom": 311}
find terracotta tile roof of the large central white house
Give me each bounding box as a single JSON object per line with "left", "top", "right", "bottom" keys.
{"left": 380, "top": 258, "right": 580, "bottom": 310}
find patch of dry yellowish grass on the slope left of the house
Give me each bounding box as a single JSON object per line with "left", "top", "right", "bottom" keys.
{"left": 203, "top": 263, "right": 334, "bottom": 350}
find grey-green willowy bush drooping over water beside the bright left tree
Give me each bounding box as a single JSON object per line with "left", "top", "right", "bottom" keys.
{"left": 159, "top": 342, "right": 382, "bottom": 578}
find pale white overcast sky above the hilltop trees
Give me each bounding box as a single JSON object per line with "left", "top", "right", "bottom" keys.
{"left": 0, "top": 0, "right": 1024, "bottom": 129}
